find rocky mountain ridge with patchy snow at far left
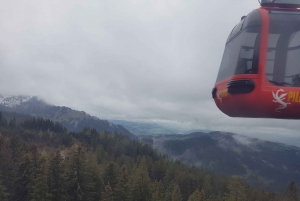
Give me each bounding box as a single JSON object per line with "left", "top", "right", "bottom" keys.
{"left": 0, "top": 95, "right": 136, "bottom": 139}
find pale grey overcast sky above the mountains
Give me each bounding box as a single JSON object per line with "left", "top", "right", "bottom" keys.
{"left": 0, "top": 0, "right": 300, "bottom": 146}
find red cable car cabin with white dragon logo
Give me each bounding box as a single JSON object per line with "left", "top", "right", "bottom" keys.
{"left": 212, "top": 0, "right": 300, "bottom": 119}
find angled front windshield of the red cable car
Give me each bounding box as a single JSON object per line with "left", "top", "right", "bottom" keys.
{"left": 217, "top": 11, "right": 261, "bottom": 82}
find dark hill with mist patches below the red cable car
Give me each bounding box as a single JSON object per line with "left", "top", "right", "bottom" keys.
{"left": 143, "top": 132, "right": 300, "bottom": 190}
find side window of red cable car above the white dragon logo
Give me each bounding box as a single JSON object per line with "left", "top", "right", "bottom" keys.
{"left": 266, "top": 12, "right": 300, "bottom": 87}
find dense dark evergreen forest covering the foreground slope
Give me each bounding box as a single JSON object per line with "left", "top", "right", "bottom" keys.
{"left": 0, "top": 113, "right": 298, "bottom": 201}
